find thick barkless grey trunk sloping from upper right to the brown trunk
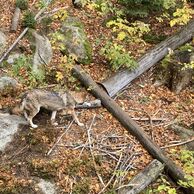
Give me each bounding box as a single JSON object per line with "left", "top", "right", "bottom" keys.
{"left": 100, "top": 20, "right": 194, "bottom": 97}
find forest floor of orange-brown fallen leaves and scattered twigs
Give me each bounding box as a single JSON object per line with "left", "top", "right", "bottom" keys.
{"left": 0, "top": 0, "right": 194, "bottom": 194}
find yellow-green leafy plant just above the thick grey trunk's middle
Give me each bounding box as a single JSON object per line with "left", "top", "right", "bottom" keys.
{"left": 100, "top": 42, "right": 137, "bottom": 70}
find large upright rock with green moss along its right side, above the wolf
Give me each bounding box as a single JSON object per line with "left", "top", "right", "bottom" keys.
{"left": 61, "top": 17, "right": 92, "bottom": 64}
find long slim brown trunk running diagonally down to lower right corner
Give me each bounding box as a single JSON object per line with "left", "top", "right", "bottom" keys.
{"left": 72, "top": 65, "right": 194, "bottom": 193}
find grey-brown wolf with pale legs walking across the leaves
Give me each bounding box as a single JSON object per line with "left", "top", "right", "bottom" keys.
{"left": 12, "top": 89, "right": 84, "bottom": 128}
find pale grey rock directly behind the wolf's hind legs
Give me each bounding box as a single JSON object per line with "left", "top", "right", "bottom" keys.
{"left": 0, "top": 113, "right": 28, "bottom": 151}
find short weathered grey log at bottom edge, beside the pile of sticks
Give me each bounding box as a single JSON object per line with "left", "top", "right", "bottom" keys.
{"left": 118, "top": 160, "right": 164, "bottom": 194}
